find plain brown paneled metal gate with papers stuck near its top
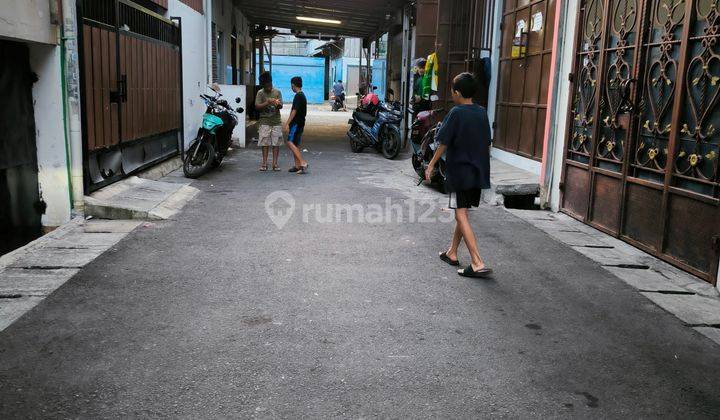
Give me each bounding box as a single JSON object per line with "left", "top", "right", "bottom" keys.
{"left": 493, "top": 0, "right": 556, "bottom": 160}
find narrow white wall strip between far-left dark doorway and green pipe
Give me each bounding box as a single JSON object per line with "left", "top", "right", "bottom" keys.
{"left": 30, "top": 44, "right": 71, "bottom": 227}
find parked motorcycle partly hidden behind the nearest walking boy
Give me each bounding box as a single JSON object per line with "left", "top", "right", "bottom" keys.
{"left": 410, "top": 108, "right": 446, "bottom": 192}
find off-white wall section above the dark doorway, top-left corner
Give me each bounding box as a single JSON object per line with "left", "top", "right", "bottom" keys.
{"left": 0, "top": 0, "right": 59, "bottom": 44}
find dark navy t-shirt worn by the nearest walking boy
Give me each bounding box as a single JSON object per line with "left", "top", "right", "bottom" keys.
{"left": 438, "top": 104, "right": 490, "bottom": 191}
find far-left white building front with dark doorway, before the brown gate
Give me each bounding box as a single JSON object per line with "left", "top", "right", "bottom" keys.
{"left": 0, "top": 0, "right": 72, "bottom": 253}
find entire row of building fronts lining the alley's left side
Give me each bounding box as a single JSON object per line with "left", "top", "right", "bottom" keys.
{"left": 0, "top": 0, "right": 252, "bottom": 254}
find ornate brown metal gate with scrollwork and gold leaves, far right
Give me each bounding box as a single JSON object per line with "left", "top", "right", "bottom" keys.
{"left": 561, "top": 0, "right": 720, "bottom": 283}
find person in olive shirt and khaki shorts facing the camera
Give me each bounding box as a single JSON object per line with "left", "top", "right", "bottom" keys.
{"left": 255, "top": 72, "right": 282, "bottom": 171}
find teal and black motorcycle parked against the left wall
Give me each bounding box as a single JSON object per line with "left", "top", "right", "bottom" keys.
{"left": 183, "top": 87, "right": 244, "bottom": 178}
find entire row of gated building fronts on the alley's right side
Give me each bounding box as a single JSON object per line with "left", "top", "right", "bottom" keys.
{"left": 413, "top": 0, "right": 720, "bottom": 284}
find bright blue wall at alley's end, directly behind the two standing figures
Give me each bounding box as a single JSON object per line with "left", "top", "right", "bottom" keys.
{"left": 258, "top": 55, "right": 325, "bottom": 104}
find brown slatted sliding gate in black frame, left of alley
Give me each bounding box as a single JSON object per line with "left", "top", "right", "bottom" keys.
{"left": 77, "top": 0, "right": 182, "bottom": 191}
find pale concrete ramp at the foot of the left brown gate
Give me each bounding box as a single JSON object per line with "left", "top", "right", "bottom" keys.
{"left": 85, "top": 176, "right": 199, "bottom": 220}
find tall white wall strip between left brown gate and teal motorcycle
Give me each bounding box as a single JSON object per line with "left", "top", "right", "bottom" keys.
{"left": 167, "top": 0, "right": 208, "bottom": 148}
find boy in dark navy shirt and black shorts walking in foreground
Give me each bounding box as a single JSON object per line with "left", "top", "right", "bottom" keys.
{"left": 425, "top": 73, "right": 492, "bottom": 277}
